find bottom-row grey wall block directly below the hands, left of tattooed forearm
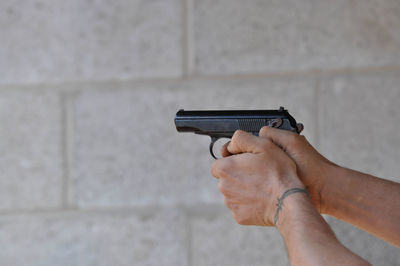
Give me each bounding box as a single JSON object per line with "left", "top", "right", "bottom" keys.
{"left": 191, "top": 209, "right": 288, "bottom": 266}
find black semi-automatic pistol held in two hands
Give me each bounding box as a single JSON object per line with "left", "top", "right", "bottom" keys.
{"left": 175, "top": 107, "right": 304, "bottom": 159}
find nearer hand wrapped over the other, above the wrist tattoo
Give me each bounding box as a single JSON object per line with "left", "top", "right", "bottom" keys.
{"left": 211, "top": 130, "right": 304, "bottom": 226}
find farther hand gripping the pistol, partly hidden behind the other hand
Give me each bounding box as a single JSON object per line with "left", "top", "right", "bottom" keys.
{"left": 221, "top": 127, "right": 338, "bottom": 213}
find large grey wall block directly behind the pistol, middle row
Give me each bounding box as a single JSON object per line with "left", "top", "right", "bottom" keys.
{"left": 71, "top": 78, "right": 314, "bottom": 206}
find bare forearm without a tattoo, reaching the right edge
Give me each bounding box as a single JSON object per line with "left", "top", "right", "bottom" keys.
{"left": 321, "top": 166, "right": 400, "bottom": 247}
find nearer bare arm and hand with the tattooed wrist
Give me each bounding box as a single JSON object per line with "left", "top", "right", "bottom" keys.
{"left": 211, "top": 131, "right": 369, "bottom": 266}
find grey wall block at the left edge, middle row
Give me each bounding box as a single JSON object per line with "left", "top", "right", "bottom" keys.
{"left": 0, "top": 90, "right": 62, "bottom": 210}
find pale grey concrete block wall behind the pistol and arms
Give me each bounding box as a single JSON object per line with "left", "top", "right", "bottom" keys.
{"left": 0, "top": 0, "right": 400, "bottom": 266}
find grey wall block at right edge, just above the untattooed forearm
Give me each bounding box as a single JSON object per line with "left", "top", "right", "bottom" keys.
{"left": 319, "top": 72, "right": 400, "bottom": 182}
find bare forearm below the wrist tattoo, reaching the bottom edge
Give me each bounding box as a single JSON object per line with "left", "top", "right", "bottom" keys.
{"left": 277, "top": 193, "right": 370, "bottom": 266}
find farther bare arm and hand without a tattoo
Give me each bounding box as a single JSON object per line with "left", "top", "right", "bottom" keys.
{"left": 258, "top": 127, "right": 400, "bottom": 247}
